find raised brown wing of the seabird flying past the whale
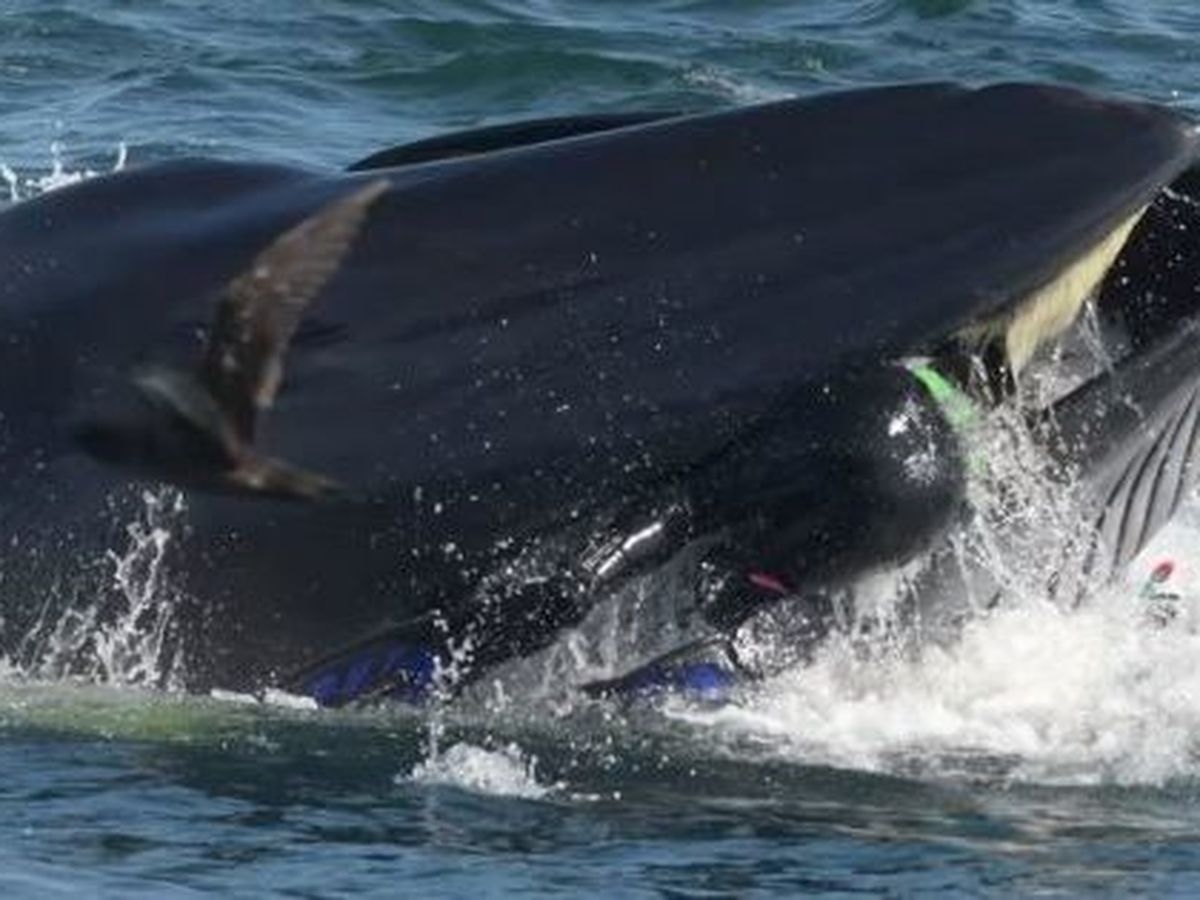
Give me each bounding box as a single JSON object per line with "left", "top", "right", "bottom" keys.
{"left": 200, "top": 179, "right": 389, "bottom": 443}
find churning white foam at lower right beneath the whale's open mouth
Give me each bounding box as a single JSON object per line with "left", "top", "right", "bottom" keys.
{"left": 674, "top": 524, "right": 1200, "bottom": 785}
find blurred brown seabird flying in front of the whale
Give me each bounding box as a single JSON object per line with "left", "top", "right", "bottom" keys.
{"left": 77, "top": 179, "right": 389, "bottom": 500}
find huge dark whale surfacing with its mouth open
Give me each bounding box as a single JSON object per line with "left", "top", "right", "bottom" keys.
{"left": 0, "top": 84, "right": 1200, "bottom": 706}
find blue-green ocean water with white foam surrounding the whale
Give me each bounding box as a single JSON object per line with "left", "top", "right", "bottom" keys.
{"left": 7, "top": 0, "right": 1200, "bottom": 896}
